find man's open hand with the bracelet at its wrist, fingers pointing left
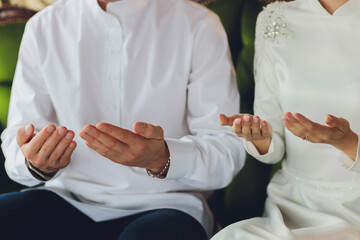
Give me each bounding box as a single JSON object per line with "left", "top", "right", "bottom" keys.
{"left": 79, "top": 122, "right": 170, "bottom": 173}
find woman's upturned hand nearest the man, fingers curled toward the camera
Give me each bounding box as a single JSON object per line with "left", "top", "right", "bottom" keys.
{"left": 219, "top": 114, "right": 272, "bottom": 155}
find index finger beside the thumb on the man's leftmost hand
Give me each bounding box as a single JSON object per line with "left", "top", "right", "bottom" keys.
{"left": 24, "top": 124, "right": 56, "bottom": 160}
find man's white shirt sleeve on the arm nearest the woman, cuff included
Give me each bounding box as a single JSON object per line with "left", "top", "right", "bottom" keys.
{"left": 166, "top": 13, "right": 245, "bottom": 189}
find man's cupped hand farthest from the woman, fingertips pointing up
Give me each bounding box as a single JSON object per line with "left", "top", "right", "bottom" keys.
{"left": 16, "top": 124, "right": 76, "bottom": 174}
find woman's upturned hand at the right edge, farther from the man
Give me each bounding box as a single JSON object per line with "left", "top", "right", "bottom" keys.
{"left": 281, "top": 112, "right": 358, "bottom": 160}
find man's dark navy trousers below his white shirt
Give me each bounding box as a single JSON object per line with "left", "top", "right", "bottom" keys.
{"left": 0, "top": 190, "right": 207, "bottom": 240}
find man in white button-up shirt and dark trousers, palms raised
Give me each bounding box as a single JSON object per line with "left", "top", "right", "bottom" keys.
{"left": 0, "top": 0, "right": 245, "bottom": 240}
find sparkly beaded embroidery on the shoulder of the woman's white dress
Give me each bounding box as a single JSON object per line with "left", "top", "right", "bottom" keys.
{"left": 262, "top": 2, "right": 293, "bottom": 44}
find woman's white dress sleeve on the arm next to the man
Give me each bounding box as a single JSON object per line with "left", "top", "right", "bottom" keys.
{"left": 245, "top": 13, "right": 285, "bottom": 163}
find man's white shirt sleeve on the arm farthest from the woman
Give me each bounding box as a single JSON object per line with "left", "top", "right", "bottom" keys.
{"left": 1, "top": 18, "right": 59, "bottom": 186}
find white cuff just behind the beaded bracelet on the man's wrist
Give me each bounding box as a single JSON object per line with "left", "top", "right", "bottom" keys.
{"left": 166, "top": 139, "right": 197, "bottom": 180}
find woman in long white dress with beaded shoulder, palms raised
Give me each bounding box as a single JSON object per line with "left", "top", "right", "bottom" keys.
{"left": 213, "top": 0, "right": 360, "bottom": 240}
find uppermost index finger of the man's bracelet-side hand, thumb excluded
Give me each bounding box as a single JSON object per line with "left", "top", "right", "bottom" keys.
{"left": 96, "top": 123, "right": 140, "bottom": 145}
